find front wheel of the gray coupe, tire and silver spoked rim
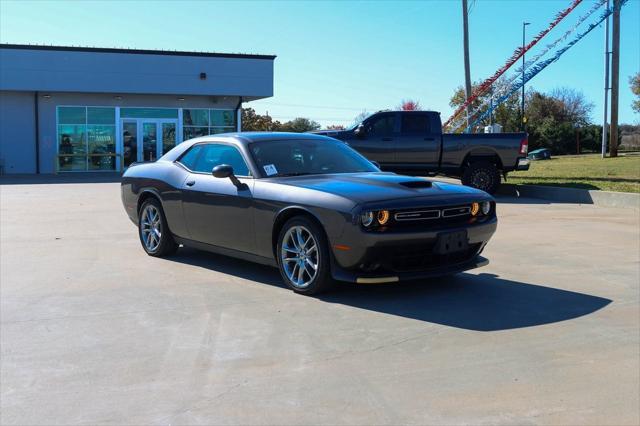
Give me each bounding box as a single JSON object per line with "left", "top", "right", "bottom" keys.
{"left": 276, "top": 216, "right": 334, "bottom": 295}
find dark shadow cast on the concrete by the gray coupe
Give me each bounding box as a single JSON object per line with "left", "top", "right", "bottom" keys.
{"left": 168, "top": 248, "right": 611, "bottom": 331}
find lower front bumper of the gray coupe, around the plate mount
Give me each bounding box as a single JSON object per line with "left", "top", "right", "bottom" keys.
{"left": 332, "top": 217, "right": 497, "bottom": 284}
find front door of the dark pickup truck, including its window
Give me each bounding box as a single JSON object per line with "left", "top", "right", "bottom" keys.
{"left": 349, "top": 112, "right": 397, "bottom": 166}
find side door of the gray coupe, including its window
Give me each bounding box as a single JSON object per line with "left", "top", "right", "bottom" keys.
{"left": 182, "top": 143, "right": 255, "bottom": 253}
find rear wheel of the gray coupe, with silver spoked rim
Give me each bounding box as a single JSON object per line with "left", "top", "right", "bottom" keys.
{"left": 138, "top": 198, "right": 178, "bottom": 257}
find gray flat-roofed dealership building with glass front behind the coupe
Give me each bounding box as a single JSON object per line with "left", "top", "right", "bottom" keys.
{"left": 0, "top": 44, "right": 275, "bottom": 174}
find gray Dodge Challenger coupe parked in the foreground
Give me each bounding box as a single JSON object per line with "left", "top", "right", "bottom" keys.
{"left": 122, "top": 132, "right": 497, "bottom": 294}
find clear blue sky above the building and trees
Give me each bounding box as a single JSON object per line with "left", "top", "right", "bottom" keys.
{"left": 0, "top": 0, "right": 640, "bottom": 126}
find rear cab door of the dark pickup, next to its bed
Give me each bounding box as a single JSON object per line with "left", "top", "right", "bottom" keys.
{"left": 395, "top": 111, "right": 441, "bottom": 171}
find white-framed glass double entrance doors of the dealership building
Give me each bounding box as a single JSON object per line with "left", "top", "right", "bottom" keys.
{"left": 122, "top": 118, "right": 178, "bottom": 167}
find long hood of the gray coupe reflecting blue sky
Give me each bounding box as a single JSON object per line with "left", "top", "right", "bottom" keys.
{"left": 272, "top": 172, "right": 491, "bottom": 204}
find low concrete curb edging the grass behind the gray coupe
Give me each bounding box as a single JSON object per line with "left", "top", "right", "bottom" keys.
{"left": 498, "top": 183, "right": 640, "bottom": 210}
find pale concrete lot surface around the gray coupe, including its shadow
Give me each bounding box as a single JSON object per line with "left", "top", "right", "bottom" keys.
{"left": 0, "top": 183, "right": 640, "bottom": 425}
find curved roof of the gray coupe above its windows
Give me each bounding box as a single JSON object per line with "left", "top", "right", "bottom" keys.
{"left": 160, "top": 132, "right": 333, "bottom": 161}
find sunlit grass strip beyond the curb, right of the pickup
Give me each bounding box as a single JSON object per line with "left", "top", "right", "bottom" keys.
{"left": 507, "top": 154, "right": 640, "bottom": 193}
